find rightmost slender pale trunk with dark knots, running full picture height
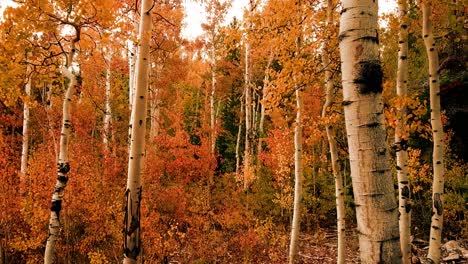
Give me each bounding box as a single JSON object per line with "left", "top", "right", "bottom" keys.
{"left": 421, "top": 0, "right": 444, "bottom": 263}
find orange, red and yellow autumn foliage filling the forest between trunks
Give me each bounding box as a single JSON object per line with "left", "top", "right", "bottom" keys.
{"left": 0, "top": 0, "right": 468, "bottom": 264}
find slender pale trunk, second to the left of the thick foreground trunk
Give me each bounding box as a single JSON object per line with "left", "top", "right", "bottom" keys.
{"left": 289, "top": 85, "right": 303, "bottom": 264}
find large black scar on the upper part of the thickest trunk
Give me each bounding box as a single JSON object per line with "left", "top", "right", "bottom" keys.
{"left": 354, "top": 61, "right": 383, "bottom": 94}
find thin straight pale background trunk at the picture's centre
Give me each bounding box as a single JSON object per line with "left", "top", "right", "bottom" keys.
{"left": 244, "top": 41, "right": 253, "bottom": 190}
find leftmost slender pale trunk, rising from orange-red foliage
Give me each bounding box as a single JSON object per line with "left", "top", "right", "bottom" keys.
{"left": 20, "top": 60, "right": 32, "bottom": 195}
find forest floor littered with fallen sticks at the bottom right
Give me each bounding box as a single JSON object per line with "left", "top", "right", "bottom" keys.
{"left": 299, "top": 231, "right": 468, "bottom": 264}
